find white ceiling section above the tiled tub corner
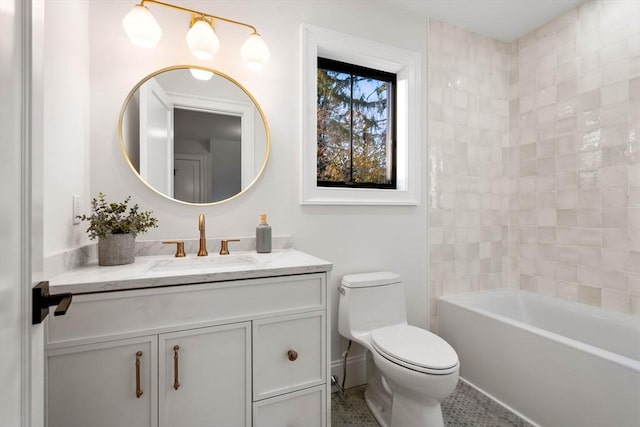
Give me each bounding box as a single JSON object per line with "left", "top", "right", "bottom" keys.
{"left": 379, "top": 0, "right": 586, "bottom": 42}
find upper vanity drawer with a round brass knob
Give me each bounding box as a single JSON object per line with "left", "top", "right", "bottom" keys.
{"left": 253, "top": 310, "right": 326, "bottom": 400}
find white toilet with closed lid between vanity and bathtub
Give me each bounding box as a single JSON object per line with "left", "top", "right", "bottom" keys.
{"left": 338, "top": 272, "right": 459, "bottom": 427}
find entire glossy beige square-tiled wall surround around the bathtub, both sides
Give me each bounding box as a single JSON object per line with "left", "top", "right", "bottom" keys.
{"left": 428, "top": 0, "right": 640, "bottom": 329}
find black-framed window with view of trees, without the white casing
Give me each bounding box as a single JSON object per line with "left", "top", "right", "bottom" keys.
{"left": 317, "top": 58, "right": 396, "bottom": 189}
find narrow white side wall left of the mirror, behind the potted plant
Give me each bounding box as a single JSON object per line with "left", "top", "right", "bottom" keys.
{"left": 44, "top": 1, "right": 91, "bottom": 256}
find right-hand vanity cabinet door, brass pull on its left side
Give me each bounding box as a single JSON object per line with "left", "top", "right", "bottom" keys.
{"left": 159, "top": 322, "right": 251, "bottom": 427}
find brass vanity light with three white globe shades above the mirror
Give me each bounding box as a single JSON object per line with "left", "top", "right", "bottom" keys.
{"left": 122, "top": 0, "right": 270, "bottom": 69}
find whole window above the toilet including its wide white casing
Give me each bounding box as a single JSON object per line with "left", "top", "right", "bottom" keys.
{"left": 300, "top": 24, "right": 426, "bottom": 205}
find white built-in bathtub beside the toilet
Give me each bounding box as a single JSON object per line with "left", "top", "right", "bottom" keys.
{"left": 438, "top": 289, "right": 640, "bottom": 427}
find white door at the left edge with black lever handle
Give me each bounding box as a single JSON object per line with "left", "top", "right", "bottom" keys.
{"left": 0, "top": 0, "right": 44, "bottom": 427}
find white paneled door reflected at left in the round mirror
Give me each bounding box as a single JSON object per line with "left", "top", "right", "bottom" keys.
{"left": 140, "top": 79, "right": 173, "bottom": 197}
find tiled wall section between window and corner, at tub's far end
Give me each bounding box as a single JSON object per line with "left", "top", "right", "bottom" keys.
{"left": 428, "top": 20, "right": 509, "bottom": 329}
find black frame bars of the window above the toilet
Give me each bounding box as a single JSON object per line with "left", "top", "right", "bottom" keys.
{"left": 316, "top": 57, "right": 398, "bottom": 190}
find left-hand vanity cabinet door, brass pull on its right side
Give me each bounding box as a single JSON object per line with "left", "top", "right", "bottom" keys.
{"left": 46, "top": 336, "right": 158, "bottom": 427}
